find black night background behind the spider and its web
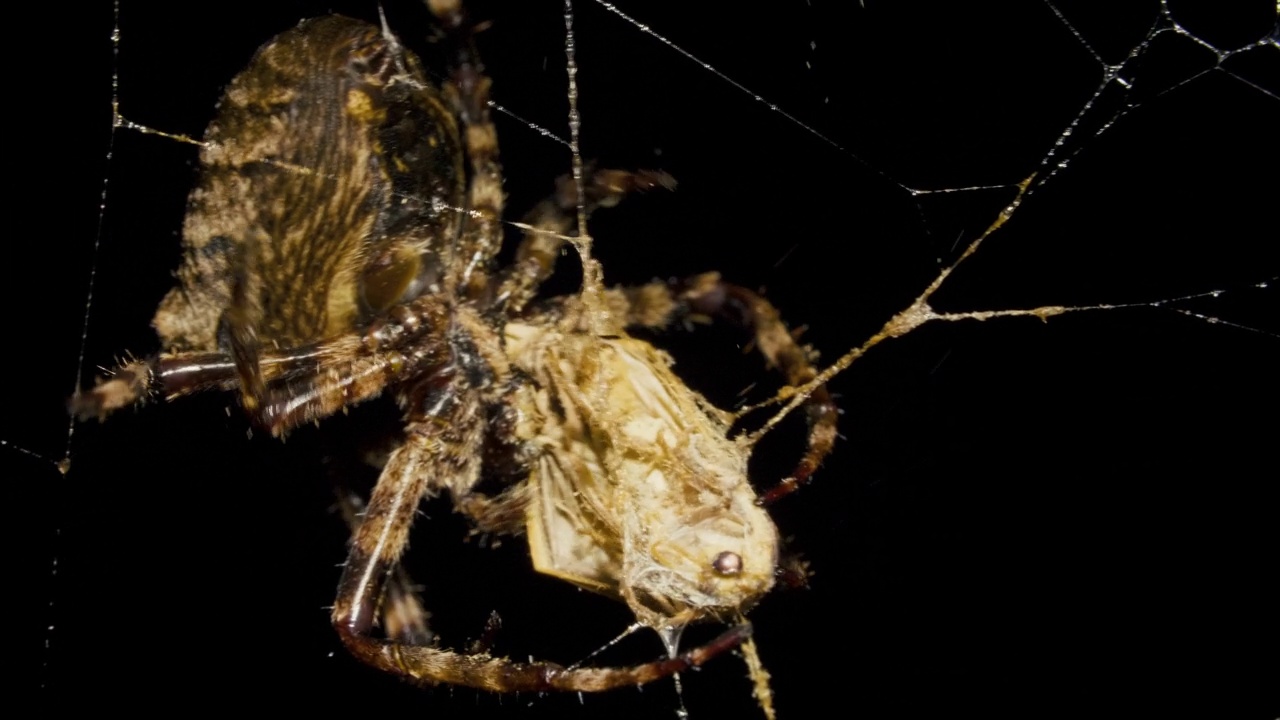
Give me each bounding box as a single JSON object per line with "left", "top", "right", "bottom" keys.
{"left": 12, "top": 0, "right": 1280, "bottom": 719}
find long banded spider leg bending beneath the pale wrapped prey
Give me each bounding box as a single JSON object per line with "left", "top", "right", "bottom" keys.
{"left": 333, "top": 371, "right": 750, "bottom": 692}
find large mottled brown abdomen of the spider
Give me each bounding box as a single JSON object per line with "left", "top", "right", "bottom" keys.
{"left": 154, "top": 15, "right": 466, "bottom": 351}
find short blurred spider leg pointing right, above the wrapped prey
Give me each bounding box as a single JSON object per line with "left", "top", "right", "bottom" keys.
{"left": 497, "top": 169, "right": 676, "bottom": 313}
